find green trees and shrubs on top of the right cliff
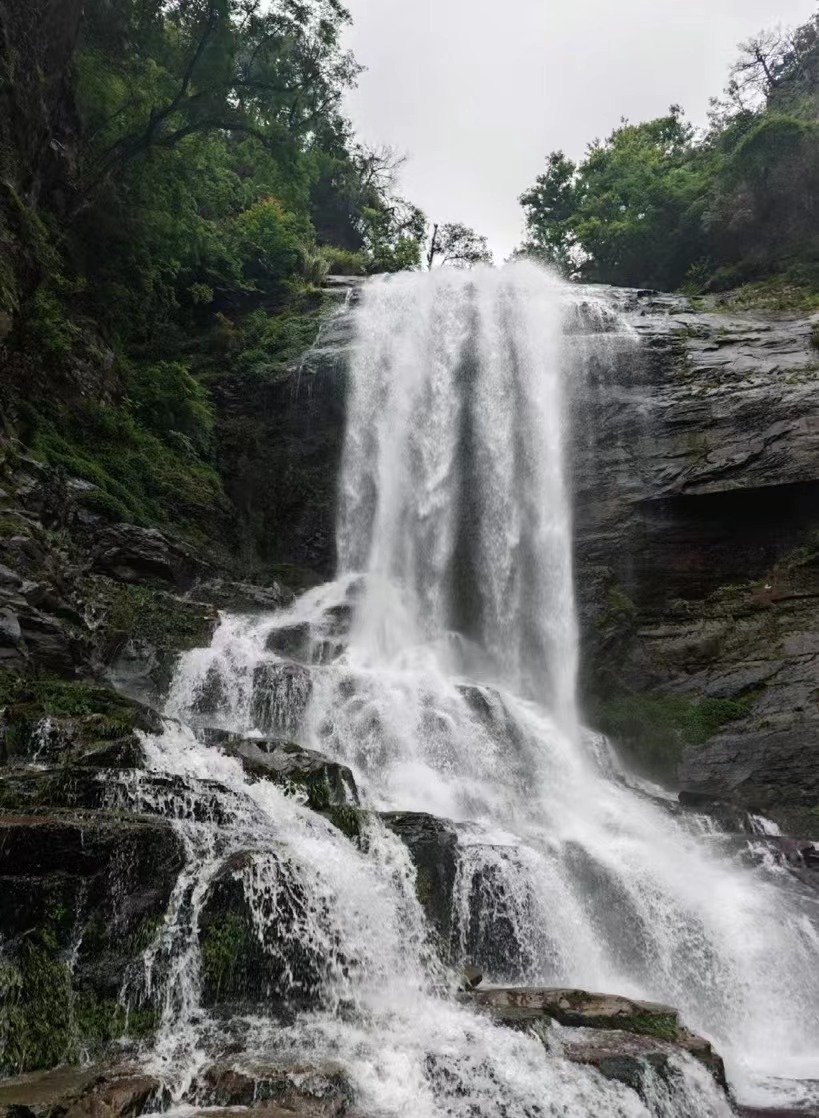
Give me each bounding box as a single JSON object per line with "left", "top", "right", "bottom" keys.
{"left": 521, "top": 13, "right": 819, "bottom": 305}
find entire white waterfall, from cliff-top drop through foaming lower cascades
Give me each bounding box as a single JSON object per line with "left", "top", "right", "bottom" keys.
{"left": 132, "top": 264, "right": 819, "bottom": 1118}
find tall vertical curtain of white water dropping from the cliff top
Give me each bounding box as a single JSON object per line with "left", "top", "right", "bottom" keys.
{"left": 339, "top": 265, "right": 578, "bottom": 729}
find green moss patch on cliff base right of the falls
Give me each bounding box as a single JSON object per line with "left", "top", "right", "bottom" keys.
{"left": 596, "top": 692, "right": 758, "bottom": 778}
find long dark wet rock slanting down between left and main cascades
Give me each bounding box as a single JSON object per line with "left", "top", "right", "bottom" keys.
{"left": 202, "top": 730, "right": 359, "bottom": 812}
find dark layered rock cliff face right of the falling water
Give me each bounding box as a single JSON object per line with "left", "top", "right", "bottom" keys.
{"left": 567, "top": 292, "right": 819, "bottom": 828}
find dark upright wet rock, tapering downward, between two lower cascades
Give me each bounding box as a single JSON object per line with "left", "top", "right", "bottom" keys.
{"left": 381, "top": 812, "right": 458, "bottom": 956}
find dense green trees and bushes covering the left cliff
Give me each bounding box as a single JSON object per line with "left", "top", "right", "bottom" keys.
{"left": 0, "top": 0, "right": 426, "bottom": 550}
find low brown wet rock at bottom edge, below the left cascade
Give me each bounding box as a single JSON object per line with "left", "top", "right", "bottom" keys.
{"left": 191, "top": 1064, "right": 352, "bottom": 1118}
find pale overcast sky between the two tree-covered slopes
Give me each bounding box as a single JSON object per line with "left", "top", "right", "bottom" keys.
{"left": 346, "top": 0, "right": 818, "bottom": 258}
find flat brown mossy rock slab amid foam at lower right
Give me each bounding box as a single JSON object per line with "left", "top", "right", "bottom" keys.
{"left": 460, "top": 987, "right": 725, "bottom": 1086}
